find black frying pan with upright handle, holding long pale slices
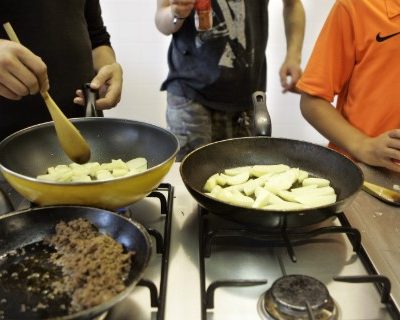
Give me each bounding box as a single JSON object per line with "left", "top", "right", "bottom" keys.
{"left": 180, "top": 92, "right": 364, "bottom": 230}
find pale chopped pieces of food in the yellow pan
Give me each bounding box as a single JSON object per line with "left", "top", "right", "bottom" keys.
{"left": 36, "top": 157, "right": 147, "bottom": 182}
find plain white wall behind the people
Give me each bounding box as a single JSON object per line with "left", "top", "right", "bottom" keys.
{"left": 101, "top": 0, "right": 334, "bottom": 143}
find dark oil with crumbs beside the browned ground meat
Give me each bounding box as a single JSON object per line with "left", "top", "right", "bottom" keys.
{"left": 0, "top": 241, "right": 71, "bottom": 320}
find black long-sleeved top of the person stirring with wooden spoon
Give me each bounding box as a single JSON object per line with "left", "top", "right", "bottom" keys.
{"left": 0, "top": 0, "right": 110, "bottom": 141}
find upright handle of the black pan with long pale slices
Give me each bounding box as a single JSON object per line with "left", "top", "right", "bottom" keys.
{"left": 252, "top": 91, "right": 272, "bottom": 137}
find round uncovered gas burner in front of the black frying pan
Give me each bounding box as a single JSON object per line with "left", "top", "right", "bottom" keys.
{"left": 258, "top": 275, "right": 338, "bottom": 320}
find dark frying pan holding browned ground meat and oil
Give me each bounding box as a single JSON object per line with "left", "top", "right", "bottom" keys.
{"left": 0, "top": 206, "right": 151, "bottom": 320}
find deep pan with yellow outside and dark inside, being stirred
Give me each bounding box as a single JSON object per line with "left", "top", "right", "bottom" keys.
{"left": 0, "top": 117, "right": 179, "bottom": 210}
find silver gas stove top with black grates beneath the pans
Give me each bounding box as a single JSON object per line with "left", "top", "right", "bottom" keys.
{"left": 0, "top": 163, "right": 400, "bottom": 320}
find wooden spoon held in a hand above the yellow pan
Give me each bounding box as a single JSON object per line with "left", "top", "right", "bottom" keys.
{"left": 3, "top": 22, "right": 90, "bottom": 163}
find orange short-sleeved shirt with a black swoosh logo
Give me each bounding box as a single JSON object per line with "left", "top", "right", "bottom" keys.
{"left": 297, "top": 0, "right": 400, "bottom": 151}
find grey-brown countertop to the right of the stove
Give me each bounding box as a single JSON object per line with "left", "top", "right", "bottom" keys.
{"left": 344, "top": 164, "right": 400, "bottom": 309}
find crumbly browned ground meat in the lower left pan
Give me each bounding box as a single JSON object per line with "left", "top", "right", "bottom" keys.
{"left": 47, "top": 218, "right": 134, "bottom": 312}
